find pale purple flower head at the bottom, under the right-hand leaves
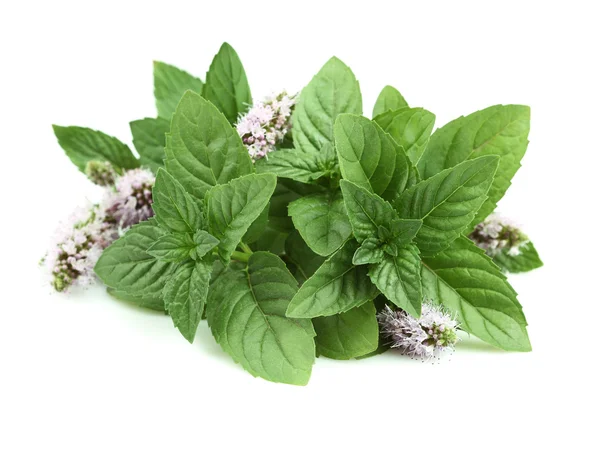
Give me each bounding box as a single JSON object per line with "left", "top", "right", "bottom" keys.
{"left": 377, "top": 302, "right": 458, "bottom": 361}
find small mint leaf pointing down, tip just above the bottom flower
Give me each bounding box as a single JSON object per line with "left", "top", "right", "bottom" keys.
{"left": 369, "top": 244, "right": 423, "bottom": 317}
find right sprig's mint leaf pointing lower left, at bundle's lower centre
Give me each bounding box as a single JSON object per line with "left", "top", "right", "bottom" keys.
{"left": 287, "top": 240, "right": 378, "bottom": 318}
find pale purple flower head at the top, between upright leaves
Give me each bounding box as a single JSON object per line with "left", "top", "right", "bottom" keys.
{"left": 236, "top": 91, "right": 296, "bottom": 161}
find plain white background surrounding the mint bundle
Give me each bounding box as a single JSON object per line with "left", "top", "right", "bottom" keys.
{"left": 0, "top": 0, "right": 600, "bottom": 450}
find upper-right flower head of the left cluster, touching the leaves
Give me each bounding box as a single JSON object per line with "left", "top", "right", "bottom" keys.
{"left": 102, "top": 169, "right": 154, "bottom": 230}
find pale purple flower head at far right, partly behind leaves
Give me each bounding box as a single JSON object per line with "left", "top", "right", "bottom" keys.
{"left": 469, "top": 213, "right": 529, "bottom": 258}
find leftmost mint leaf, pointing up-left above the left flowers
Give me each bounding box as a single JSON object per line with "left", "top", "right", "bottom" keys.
{"left": 52, "top": 125, "right": 140, "bottom": 173}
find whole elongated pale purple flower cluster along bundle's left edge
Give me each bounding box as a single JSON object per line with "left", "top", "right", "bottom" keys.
{"left": 43, "top": 166, "right": 154, "bottom": 292}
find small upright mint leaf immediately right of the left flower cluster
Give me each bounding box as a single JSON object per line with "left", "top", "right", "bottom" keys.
{"left": 152, "top": 168, "right": 204, "bottom": 233}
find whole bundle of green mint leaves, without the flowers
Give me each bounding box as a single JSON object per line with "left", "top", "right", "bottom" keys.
{"left": 49, "top": 44, "right": 542, "bottom": 385}
